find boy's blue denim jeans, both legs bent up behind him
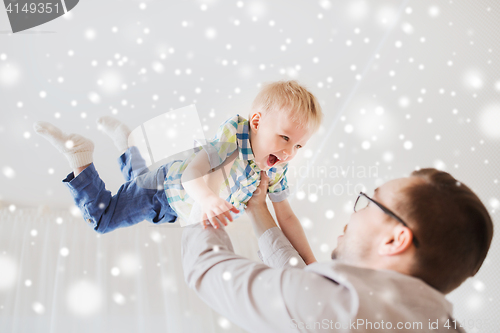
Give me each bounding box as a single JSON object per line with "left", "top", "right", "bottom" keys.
{"left": 63, "top": 146, "right": 177, "bottom": 234}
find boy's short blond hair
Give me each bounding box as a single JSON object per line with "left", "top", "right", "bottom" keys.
{"left": 250, "top": 80, "right": 323, "bottom": 132}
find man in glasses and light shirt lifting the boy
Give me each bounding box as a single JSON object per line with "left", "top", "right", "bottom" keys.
{"left": 182, "top": 169, "right": 493, "bottom": 333}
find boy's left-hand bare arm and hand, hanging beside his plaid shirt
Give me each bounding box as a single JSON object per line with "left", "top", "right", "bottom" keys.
{"left": 181, "top": 150, "right": 239, "bottom": 228}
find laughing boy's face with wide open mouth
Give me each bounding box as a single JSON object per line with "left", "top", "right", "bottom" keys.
{"left": 249, "top": 110, "right": 312, "bottom": 170}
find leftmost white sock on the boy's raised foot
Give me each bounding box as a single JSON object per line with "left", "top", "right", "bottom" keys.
{"left": 33, "top": 121, "right": 94, "bottom": 169}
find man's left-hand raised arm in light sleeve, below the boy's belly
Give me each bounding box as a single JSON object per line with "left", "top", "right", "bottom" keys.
{"left": 182, "top": 224, "right": 300, "bottom": 333}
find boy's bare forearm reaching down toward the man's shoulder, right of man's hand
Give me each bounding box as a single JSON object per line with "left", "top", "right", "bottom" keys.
{"left": 273, "top": 199, "right": 317, "bottom": 265}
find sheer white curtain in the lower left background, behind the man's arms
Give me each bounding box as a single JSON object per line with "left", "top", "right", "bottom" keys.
{"left": 0, "top": 208, "right": 259, "bottom": 333}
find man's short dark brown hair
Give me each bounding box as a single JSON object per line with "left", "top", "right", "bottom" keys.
{"left": 398, "top": 168, "right": 493, "bottom": 294}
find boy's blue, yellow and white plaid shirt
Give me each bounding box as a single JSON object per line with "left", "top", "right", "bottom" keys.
{"left": 164, "top": 115, "right": 290, "bottom": 222}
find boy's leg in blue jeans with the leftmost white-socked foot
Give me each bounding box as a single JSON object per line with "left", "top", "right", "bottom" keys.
{"left": 33, "top": 121, "right": 176, "bottom": 233}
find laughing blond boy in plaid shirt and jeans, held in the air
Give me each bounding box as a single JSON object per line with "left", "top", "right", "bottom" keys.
{"left": 34, "top": 81, "right": 322, "bottom": 264}
